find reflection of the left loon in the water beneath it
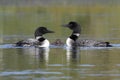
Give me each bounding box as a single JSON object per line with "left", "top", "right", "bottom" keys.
{"left": 18, "top": 47, "right": 50, "bottom": 65}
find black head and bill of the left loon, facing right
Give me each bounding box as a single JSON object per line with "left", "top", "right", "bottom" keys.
{"left": 34, "top": 27, "right": 54, "bottom": 38}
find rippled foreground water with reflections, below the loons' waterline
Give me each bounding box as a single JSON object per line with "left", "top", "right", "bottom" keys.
{"left": 0, "top": 44, "right": 120, "bottom": 80}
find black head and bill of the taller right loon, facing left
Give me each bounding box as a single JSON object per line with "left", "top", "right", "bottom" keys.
{"left": 63, "top": 21, "right": 81, "bottom": 33}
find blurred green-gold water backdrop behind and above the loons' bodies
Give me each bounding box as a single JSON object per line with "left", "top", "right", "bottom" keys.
{"left": 0, "top": 1, "right": 120, "bottom": 43}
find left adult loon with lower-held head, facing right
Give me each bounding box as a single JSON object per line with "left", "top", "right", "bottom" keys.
{"left": 16, "top": 27, "right": 54, "bottom": 47}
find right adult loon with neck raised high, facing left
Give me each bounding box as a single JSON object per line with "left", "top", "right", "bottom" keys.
{"left": 63, "top": 21, "right": 112, "bottom": 47}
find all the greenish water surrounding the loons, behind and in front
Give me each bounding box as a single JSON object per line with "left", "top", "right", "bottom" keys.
{"left": 0, "top": 0, "right": 120, "bottom": 80}
